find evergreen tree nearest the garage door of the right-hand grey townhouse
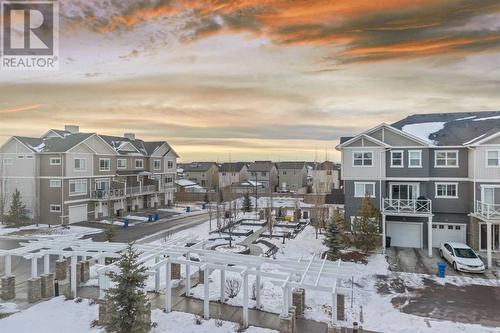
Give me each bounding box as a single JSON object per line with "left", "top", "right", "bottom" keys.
{"left": 351, "top": 196, "right": 380, "bottom": 253}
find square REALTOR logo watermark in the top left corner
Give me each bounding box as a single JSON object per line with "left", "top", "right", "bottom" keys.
{"left": 0, "top": 0, "right": 59, "bottom": 70}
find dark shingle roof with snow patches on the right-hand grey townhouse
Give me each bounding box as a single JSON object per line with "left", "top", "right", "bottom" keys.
{"left": 392, "top": 111, "right": 500, "bottom": 146}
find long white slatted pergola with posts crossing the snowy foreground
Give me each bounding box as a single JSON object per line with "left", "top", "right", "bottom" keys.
{"left": 0, "top": 237, "right": 353, "bottom": 326}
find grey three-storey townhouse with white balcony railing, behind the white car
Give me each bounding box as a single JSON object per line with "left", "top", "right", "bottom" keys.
{"left": 337, "top": 112, "right": 500, "bottom": 267}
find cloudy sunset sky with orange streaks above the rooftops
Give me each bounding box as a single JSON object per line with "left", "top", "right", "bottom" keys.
{"left": 0, "top": 0, "right": 500, "bottom": 162}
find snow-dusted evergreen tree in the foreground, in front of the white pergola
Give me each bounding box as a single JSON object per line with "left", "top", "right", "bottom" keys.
{"left": 105, "top": 243, "right": 151, "bottom": 333}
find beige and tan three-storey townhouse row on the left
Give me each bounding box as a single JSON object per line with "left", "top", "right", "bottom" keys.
{"left": 0, "top": 126, "right": 178, "bottom": 224}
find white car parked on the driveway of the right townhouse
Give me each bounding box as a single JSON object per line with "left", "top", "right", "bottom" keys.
{"left": 439, "top": 242, "right": 484, "bottom": 273}
